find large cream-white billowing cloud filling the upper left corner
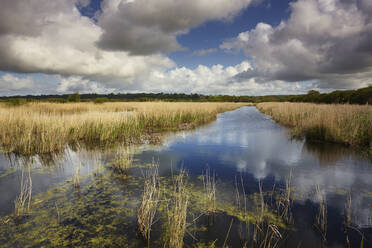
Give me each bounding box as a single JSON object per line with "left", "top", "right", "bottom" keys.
{"left": 0, "top": 0, "right": 174, "bottom": 83}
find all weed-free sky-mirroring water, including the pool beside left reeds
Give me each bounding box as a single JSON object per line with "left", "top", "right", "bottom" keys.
{"left": 0, "top": 107, "right": 372, "bottom": 247}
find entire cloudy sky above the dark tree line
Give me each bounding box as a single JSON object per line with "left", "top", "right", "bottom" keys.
{"left": 0, "top": 0, "right": 372, "bottom": 96}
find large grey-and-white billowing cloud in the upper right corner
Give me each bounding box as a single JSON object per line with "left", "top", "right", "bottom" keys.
{"left": 220, "top": 0, "right": 372, "bottom": 88}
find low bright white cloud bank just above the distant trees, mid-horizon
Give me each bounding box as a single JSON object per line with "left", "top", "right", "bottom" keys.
{"left": 50, "top": 61, "right": 317, "bottom": 95}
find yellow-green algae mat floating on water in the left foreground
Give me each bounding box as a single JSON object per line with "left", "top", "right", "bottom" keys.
{"left": 0, "top": 165, "right": 286, "bottom": 247}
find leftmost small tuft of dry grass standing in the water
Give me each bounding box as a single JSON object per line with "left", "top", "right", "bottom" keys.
{"left": 14, "top": 168, "right": 32, "bottom": 218}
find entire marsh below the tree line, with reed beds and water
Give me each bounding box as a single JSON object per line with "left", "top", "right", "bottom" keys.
{"left": 0, "top": 102, "right": 372, "bottom": 248}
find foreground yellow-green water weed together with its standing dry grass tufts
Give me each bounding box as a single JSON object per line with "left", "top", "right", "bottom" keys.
{"left": 0, "top": 154, "right": 370, "bottom": 248}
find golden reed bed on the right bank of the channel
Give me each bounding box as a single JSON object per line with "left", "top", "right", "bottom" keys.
{"left": 257, "top": 103, "right": 372, "bottom": 149}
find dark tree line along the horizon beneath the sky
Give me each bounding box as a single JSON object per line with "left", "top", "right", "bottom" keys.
{"left": 0, "top": 86, "right": 372, "bottom": 105}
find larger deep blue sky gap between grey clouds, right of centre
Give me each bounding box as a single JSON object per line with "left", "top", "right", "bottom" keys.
{"left": 169, "top": 0, "right": 290, "bottom": 68}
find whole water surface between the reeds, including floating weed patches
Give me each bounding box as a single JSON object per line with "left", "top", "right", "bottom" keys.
{"left": 0, "top": 107, "right": 372, "bottom": 247}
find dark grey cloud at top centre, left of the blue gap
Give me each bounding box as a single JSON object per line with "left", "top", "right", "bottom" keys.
{"left": 97, "top": 0, "right": 252, "bottom": 55}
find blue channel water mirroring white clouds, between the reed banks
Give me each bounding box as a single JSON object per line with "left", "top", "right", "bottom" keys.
{"left": 139, "top": 107, "right": 372, "bottom": 230}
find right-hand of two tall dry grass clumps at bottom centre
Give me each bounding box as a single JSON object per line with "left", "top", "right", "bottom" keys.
{"left": 164, "top": 170, "right": 189, "bottom": 248}
